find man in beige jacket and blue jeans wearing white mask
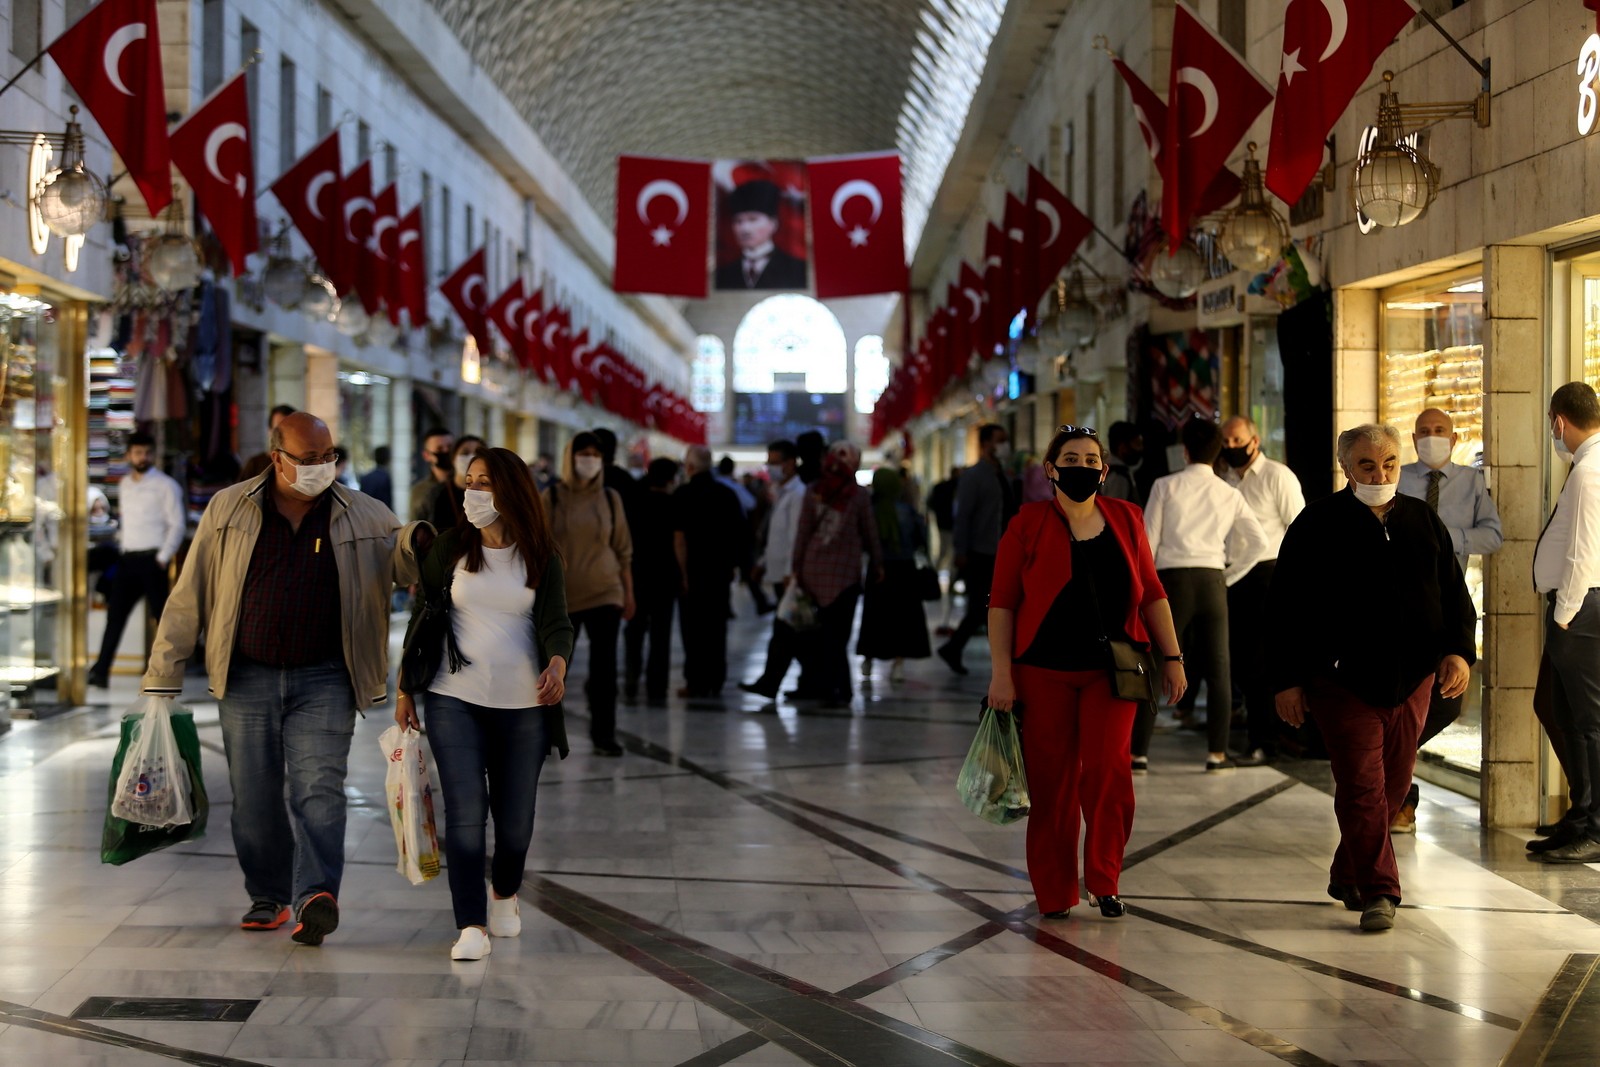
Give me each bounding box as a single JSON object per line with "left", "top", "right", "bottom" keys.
{"left": 144, "top": 411, "right": 434, "bottom": 945}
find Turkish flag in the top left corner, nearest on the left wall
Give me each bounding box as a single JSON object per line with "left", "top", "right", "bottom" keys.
{"left": 46, "top": 0, "right": 173, "bottom": 218}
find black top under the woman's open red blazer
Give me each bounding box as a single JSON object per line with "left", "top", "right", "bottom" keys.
{"left": 1016, "top": 525, "right": 1133, "bottom": 670}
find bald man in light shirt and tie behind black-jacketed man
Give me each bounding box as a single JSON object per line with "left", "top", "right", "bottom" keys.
{"left": 1389, "top": 408, "right": 1504, "bottom": 833}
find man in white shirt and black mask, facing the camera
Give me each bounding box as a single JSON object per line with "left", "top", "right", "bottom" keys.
{"left": 1218, "top": 414, "right": 1306, "bottom": 766}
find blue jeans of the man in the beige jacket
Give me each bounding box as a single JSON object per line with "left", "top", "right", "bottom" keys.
{"left": 218, "top": 657, "right": 355, "bottom": 905}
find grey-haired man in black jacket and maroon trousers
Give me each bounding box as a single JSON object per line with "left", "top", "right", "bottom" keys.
{"left": 1269, "top": 426, "right": 1477, "bottom": 931}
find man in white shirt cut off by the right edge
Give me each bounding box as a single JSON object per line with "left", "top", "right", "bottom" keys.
{"left": 1528, "top": 382, "right": 1600, "bottom": 864}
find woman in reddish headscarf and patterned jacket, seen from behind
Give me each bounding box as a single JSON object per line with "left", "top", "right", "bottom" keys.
{"left": 794, "top": 442, "right": 883, "bottom": 707}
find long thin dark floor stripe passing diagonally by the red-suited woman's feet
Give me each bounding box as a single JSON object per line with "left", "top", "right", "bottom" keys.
{"left": 604, "top": 731, "right": 1328, "bottom": 1067}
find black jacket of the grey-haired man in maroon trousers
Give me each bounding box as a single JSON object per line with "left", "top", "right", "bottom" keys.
{"left": 1267, "top": 488, "right": 1477, "bottom": 707}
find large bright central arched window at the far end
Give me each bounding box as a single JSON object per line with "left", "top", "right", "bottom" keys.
{"left": 733, "top": 293, "right": 848, "bottom": 394}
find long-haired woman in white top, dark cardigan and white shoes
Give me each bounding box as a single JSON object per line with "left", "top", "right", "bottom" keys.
{"left": 395, "top": 448, "right": 573, "bottom": 960}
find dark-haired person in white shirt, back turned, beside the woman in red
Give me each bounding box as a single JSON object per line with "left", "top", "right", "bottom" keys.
{"left": 1133, "top": 418, "right": 1267, "bottom": 771}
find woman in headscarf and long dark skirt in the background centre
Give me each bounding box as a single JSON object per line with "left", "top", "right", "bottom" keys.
{"left": 856, "top": 467, "right": 933, "bottom": 681}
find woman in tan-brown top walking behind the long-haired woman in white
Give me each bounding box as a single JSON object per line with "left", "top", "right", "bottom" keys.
{"left": 542, "top": 432, "right": 634, "bottom": 757}
